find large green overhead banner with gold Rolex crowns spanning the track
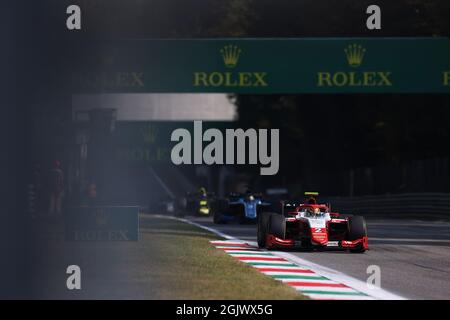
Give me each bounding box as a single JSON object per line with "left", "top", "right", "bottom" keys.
{"left": 71, "top": 38, "right": 450, "bottom": 94}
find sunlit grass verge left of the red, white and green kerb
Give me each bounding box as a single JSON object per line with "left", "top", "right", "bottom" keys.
{"left": 140, "top": 216, "right": 305, "bottom": 299}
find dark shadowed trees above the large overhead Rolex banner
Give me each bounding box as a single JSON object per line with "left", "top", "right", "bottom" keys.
{"left": 74, "top": 0, "right": 450, "bottom": 38}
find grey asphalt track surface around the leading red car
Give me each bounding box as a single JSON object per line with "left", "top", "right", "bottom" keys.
{"left": 189, "top": 217, "right": 450, "bottom": 299}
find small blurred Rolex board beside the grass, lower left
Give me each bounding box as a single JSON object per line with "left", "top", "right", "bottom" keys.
{"left": 65, "top": 206, "right": 139, "bottom": 241}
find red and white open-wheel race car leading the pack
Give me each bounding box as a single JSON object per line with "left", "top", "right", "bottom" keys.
{"left": 257, "top": 192, "right": 369, "bottom": 253}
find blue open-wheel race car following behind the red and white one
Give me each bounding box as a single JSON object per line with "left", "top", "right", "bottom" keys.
{"left": 213, "top": 193, "right": 269, "bottom": 224}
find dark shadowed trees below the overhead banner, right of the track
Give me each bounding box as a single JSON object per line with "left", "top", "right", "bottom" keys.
{"left": 236, "top": 95, "right": 450, "bottom": 175}
